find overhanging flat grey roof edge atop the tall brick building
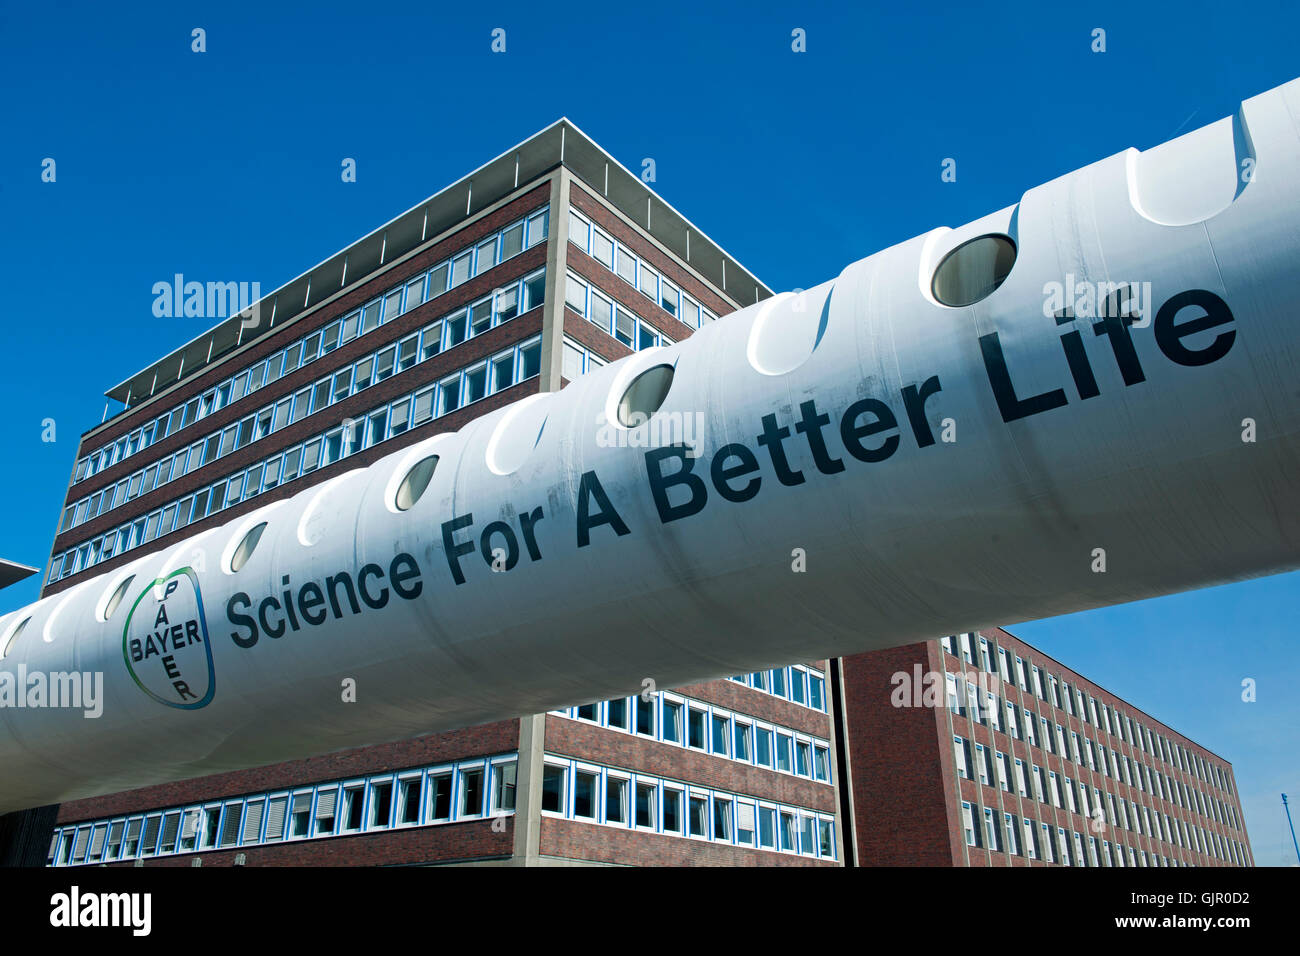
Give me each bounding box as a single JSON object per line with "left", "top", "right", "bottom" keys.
{"left": 109, "top": 117, "right": 772, "bottom": 416}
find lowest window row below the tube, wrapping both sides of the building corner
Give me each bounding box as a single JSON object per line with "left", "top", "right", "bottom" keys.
{"left": 48, "top": 753, "right": 836, "bottom": 866}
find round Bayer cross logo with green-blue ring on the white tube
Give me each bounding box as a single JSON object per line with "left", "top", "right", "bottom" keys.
{"left": 122, "top": 567, "right": 217, "bottom": 710}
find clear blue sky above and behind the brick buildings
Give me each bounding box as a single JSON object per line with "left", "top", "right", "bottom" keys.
{"left": 0, "top": 0, "right": 1300, "bottom": 865}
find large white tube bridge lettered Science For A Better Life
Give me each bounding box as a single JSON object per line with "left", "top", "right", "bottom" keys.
{"left": 0, "top": 81, "right": 1300, "bottom": 810}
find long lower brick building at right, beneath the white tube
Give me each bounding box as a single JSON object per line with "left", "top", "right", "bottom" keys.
{"left": 842, "top": 628, "right": 1253, "bottom": 866}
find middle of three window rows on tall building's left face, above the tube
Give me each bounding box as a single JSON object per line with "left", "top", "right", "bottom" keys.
{"left": 60, "top": 269, "right": 546, "bottom": 532}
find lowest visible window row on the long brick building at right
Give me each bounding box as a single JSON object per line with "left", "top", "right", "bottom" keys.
{"left": 962, "top": 801, "right": 1249, "bottom": 866}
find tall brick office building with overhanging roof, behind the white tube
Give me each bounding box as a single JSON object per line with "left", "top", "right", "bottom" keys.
{"left": 35, "top": 121, "right": 839, "bottom": 865}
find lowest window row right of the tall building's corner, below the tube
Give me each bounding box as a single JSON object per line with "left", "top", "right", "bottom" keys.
{"left": 542, "top": 754, "right": 836, "bottom": 860}
